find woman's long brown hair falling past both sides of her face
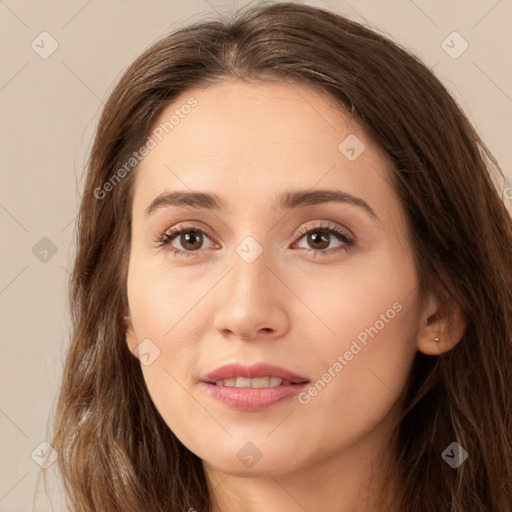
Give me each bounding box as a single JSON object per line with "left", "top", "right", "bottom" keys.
{"left": 51, "top": 2, "right": 512, "bottom": 512}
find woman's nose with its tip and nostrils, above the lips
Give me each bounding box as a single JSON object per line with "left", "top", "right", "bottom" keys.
{"left": 214, "top": 246, "right": 291, "bottom": 340}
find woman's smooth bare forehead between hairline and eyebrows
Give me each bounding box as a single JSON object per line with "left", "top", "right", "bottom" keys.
{"left": 134, "top": 80, "right": 389, "bottom": 216}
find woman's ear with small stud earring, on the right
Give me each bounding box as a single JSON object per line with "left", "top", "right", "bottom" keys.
{"left": 417, "top": 294, "right": 468, "bottom": 355}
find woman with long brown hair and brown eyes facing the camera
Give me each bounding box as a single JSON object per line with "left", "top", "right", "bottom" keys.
{"left": 52, "top": 3, "right": 512, "bottom": 512}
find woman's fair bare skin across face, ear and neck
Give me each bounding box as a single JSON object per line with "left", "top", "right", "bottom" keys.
{"left": 126, "top": 80, "right": 465, "bottom": 512}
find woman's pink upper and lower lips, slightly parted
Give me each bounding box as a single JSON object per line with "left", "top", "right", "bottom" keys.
{"left": 201, "top": 363, "right": 309, "bottom": 411}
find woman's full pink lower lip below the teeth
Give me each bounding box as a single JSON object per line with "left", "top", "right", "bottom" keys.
{"left": 202, "top": 382, "right": 309, "bottom": 411}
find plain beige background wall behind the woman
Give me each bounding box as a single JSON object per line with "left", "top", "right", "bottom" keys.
{"left": 0, "top": 0, "right": 512, "bottom": 512}
